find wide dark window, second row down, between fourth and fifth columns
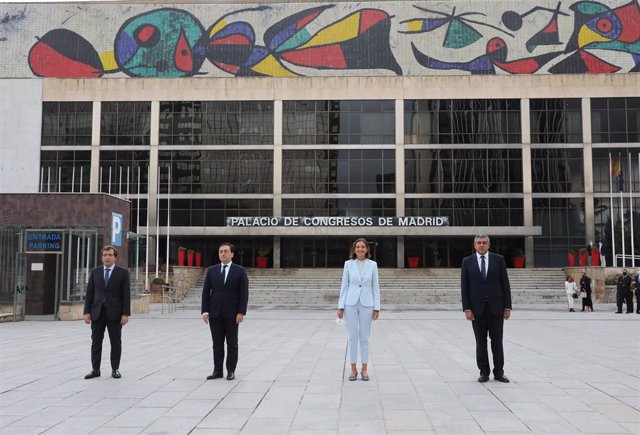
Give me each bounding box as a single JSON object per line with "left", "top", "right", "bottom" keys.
{"left": 405, "top": 149, "right": 522, "bottom": 193}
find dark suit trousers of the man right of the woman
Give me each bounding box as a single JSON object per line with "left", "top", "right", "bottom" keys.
{"left": 471, "top": 305, "right": 504, "bottom": 376}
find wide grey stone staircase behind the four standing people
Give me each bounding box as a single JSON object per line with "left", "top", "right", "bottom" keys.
{"left": 178, "top": 268, "right": 566, "bottom": 309}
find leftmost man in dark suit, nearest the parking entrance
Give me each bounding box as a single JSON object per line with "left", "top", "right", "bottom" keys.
{"left": 84, "top": 245, "right": 131, "bottom": 379}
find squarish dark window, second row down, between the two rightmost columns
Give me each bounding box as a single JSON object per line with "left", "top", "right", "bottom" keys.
{"left": 531, "top": 148, "right": 584, "bottom": 192}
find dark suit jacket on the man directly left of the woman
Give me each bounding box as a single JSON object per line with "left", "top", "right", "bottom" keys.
{"left": 201, "top": 263, "right": 249, "bottom": 319}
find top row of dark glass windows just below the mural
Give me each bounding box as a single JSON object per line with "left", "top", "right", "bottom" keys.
{"left": 42, "top": 97, "right": 640, "bottom": 146}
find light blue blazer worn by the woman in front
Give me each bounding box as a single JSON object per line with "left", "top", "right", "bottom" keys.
{"left": 338, "top": 259, "right": 380, "bottom": 311}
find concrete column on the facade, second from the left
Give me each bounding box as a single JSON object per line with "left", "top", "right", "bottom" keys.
{"left": 145, "top": 101, "right": 162, "bottom": 262}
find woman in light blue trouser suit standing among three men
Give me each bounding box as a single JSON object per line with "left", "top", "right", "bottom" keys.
{"left": 338, "top": 239, "right": 380, "bottom": 381}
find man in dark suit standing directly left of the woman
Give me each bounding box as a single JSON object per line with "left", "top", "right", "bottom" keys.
{"left": 202, "top": 242, "right": 249, "bottom": 381}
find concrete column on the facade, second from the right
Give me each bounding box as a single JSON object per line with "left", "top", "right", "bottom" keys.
{"left": 520, "top": 98, "right": 535, "bottom": 267}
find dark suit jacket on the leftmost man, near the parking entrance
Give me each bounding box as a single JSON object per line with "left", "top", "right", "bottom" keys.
{"left": 84, "top": 265, "right": 131, "bottom": 322}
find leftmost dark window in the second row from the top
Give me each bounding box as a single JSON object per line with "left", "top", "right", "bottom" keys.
{"left": 40, "top": 151, "right": 91, "bottom": 192}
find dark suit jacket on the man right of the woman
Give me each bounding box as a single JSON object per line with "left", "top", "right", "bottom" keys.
{"left": 461, "top": 252, "right": 511, "bottom": 316}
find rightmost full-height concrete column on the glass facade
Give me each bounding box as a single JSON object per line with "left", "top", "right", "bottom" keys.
{"left": 581, "top": 97, "right": 598, "bottom": 249}
